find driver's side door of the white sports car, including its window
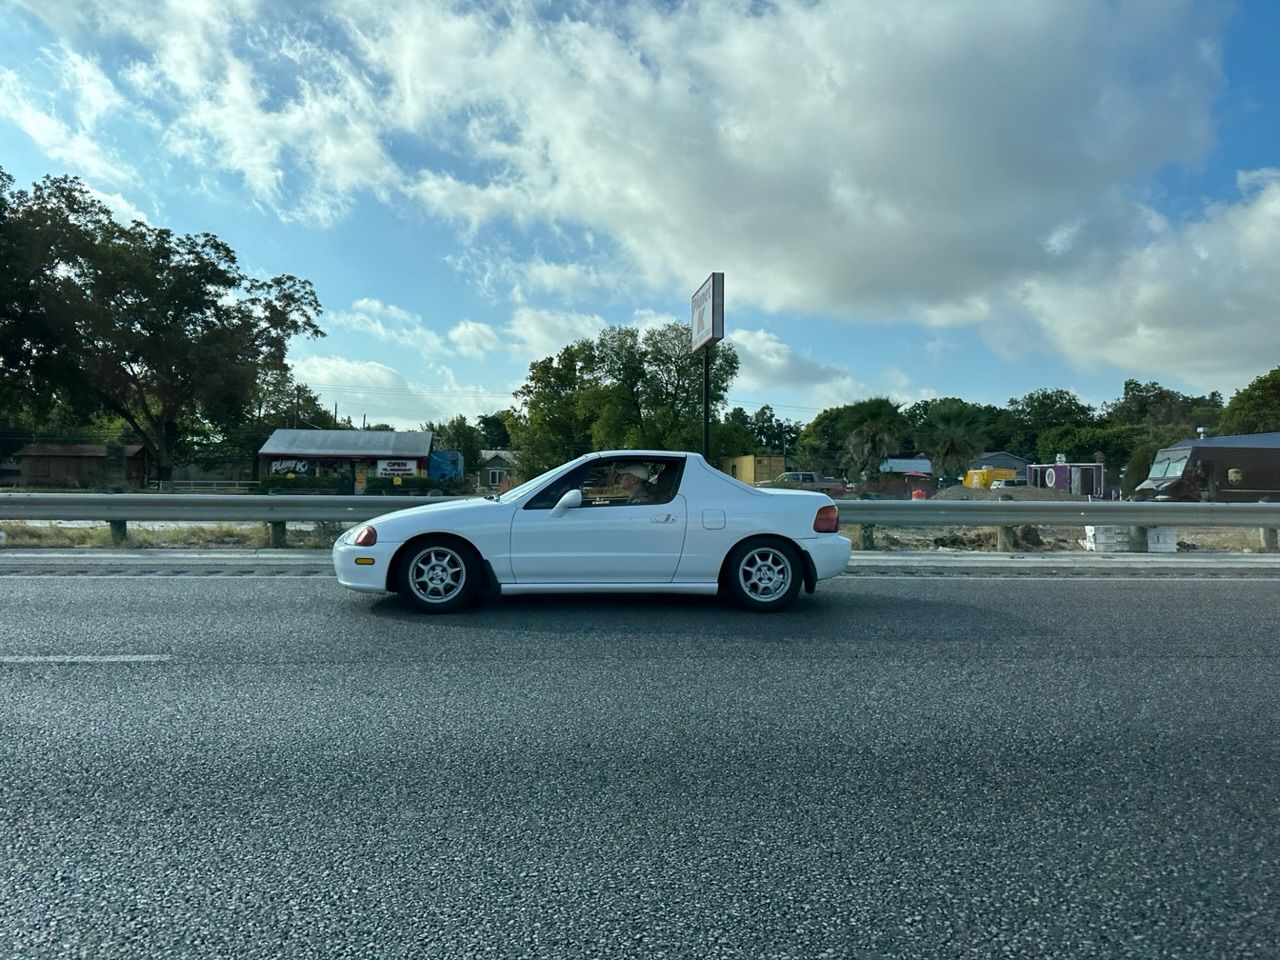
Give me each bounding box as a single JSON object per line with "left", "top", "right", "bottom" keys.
{"left": 511, "top": 457, "right": 689, "bottom": 584}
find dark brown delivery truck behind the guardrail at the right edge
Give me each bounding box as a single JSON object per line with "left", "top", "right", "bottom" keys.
{"left": 1133, "top": 433, "right": 1280, "bottom": 503}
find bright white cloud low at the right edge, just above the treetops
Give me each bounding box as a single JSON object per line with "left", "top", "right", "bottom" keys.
{"left": 1019, "top": 168, "right": 1280, "bottom": 389}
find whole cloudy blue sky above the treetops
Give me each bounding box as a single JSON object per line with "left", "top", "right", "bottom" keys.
{"left": 0, "top": 0, "right": 1280, "bottom": 428}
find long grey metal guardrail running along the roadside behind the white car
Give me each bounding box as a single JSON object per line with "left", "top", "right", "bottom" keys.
{"left": 0, "top": 493, "right": 1280, "bottom": 527}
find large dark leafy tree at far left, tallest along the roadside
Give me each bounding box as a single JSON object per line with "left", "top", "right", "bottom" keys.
{"left": 0, "top": 171, "right": 324, "bottom": 480}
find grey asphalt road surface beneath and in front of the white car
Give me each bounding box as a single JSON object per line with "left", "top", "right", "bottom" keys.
{"left": 0, "top": 571, "right": 1280, "bottom": 960}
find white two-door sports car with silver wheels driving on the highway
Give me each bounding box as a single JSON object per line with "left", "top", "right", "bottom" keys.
{"left": 333, "top": 451, "right": 851, "bottom": 613}
